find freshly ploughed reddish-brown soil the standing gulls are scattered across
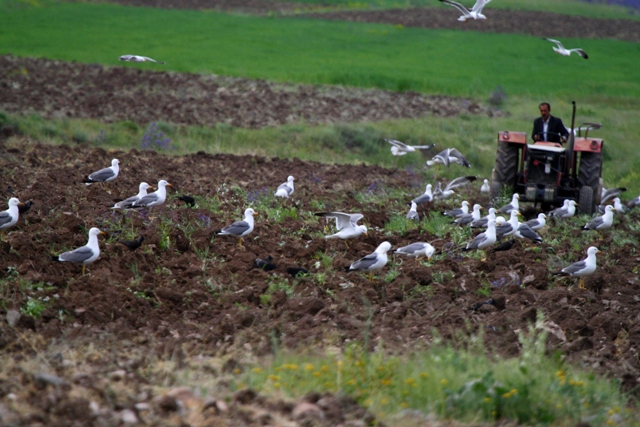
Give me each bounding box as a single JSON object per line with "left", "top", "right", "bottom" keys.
{"left": 0, "top": 145, "right": 640, "bottom": 425}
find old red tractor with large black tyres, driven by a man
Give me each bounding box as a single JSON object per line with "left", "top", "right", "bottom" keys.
{"left": 491, "top": 101, "right": 603, "bottom": 214}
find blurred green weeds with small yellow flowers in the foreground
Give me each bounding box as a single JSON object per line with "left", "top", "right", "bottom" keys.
{"left": 235, "top": 316, "right": 640, "bottom": 425}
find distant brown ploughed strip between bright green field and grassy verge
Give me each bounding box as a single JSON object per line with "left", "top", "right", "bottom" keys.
{"left": 0, "top": 56, "right": 493, "bottom": 128}
